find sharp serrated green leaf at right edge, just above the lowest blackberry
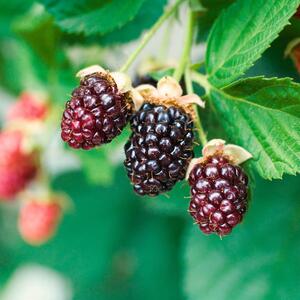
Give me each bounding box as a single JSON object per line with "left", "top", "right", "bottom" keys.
{"left": 209, "top": 77, "right": 300, "bottom": 179}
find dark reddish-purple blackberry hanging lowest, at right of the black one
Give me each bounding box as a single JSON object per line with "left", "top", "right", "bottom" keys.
{"left": 189, "top": 154, "right": 248, "bottom": 236}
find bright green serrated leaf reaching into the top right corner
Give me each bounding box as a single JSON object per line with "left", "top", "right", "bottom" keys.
{"left": 206, "top": 0, "right": 300, "bottom": 87}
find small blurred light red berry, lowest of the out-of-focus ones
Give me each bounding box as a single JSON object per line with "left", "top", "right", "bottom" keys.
{"left": 18, "top": 200, "right": 61, "bottom": 245}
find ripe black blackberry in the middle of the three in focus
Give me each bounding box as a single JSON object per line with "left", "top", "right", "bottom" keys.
{"left": 124, "top": 103, "right": 194, "bottom": 196}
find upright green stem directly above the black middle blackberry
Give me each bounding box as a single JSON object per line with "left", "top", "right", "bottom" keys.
{"left": 173, "top": 9, "right": 195, "bottom": 81}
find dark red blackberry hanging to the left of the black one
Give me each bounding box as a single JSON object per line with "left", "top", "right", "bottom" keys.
{"left": 61, "top": 73, "right": 132, "bottom": 150}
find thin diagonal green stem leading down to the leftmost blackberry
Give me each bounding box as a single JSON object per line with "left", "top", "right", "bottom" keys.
{"left": 120, "top": 0, "right": 185, "bottom": 72}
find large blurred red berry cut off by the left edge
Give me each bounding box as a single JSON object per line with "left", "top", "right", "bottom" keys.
{"left": 0, "top": 131, "right": 37, "bottom": 200}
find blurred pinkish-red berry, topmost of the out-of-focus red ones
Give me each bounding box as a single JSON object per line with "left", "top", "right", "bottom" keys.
{"left": 7, "top": 92, "right": 48, "bottom": 121}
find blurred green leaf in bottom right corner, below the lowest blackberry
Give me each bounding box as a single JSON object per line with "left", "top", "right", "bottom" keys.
{"left": 184, "top": 177, "right": 300, "bottom": 300}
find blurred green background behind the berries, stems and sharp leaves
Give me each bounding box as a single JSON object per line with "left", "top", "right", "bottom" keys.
{"left": 0, "top": 0, "right": 300, "bottom": 300}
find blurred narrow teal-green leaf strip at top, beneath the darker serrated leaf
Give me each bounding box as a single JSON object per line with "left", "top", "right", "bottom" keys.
{"left": 99, "top": 0, "right": 167, "bottom": 46}
